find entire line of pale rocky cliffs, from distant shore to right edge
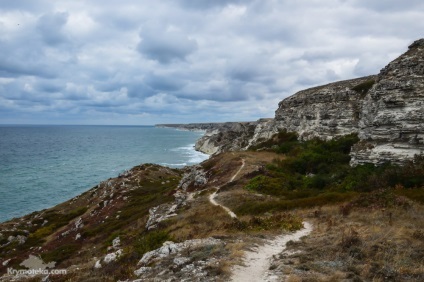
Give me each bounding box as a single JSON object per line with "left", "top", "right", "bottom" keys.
{"left": 163, "top": 39, "right": 424, "bottom": 165}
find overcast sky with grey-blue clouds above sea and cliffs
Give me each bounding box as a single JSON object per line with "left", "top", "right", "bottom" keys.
{"left": 0, "top": 0, "right": 424, "bottom": 125}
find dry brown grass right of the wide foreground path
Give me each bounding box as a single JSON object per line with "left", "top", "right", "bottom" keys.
{"left": 279, "top": 204, "right": 424, "bottom": 281}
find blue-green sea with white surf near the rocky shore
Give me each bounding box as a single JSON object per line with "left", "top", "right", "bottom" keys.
{"left": 0, "top": 125, "right": 208, "bottom": 222}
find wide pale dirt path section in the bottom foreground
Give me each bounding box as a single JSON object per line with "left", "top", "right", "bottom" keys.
{"left": 230, "top": 222, "right": 312, "bottom": 282}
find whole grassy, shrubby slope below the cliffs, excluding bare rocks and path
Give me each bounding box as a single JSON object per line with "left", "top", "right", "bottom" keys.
{"left": 0, "top": 132, "right": 424, "bottom": 281}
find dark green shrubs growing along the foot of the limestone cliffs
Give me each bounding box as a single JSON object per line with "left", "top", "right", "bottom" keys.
{"left": 236, "top": 131, "right": 424, "bottom": 214}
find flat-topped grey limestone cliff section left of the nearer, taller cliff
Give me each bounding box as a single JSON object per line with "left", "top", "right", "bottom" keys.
{"left": 275, "top": 76, "right": 376, "bottom": 140}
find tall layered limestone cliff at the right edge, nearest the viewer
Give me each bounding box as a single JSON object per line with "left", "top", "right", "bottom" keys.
{"left": 351, "top": 39, "right": 424, "bottom": 165}
